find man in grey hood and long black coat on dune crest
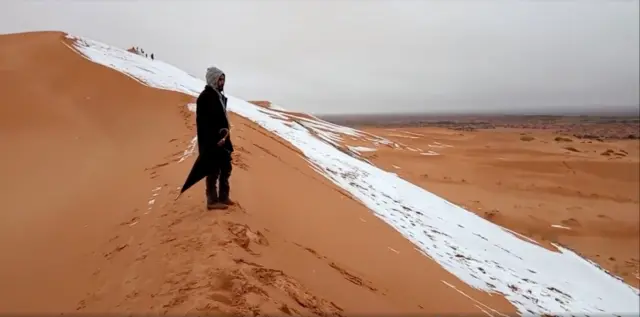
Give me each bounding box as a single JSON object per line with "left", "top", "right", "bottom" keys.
{"left": 196, "top": 67, "right": 233, "bottom": 210}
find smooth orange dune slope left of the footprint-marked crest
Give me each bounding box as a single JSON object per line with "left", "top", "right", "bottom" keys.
{"left": 0, "top": 33, "right": 192, "bottom": 310}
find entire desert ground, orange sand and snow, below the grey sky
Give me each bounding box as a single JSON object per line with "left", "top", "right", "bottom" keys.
{"left": 0, "top": 32, "right": 640, "bottom": 317}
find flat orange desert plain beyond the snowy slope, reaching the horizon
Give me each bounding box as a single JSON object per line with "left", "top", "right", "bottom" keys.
{"left": 322, "top": 111, "right": 640, "bottom": 287}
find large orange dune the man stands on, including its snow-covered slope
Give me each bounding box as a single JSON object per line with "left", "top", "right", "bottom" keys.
{"left": 0, "top": 32, "right": 638, "bottom": 316}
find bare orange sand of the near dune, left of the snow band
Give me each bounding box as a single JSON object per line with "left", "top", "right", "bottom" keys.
{"left": 0, "top": 32, "right": 520, "bottom": 316}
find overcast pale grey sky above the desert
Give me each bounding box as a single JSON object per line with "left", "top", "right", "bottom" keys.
{"left": 0, "top": 0, "right": 640, "bottom": 113}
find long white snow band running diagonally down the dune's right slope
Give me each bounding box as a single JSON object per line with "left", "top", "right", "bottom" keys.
{"left": 66, "top": 33, "right": 640, "bottom": 315}
